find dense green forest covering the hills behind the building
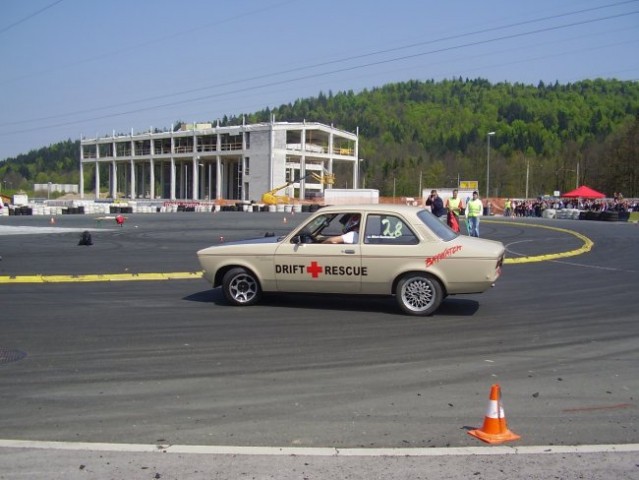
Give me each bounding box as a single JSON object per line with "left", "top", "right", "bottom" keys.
{"left": 0, "top": 78, "right": 639, "bottom": 198}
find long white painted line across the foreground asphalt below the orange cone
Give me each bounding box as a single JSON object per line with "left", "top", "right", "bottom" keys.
{"left": 0, "top": 439, "right": 639, "bottom": 457}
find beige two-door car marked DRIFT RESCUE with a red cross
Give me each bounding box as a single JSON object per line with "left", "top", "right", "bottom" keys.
{"left": 197, "top": 205, "right": 505, "bottom": 315}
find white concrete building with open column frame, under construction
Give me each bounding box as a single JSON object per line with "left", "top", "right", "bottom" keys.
{"left": 80, "top": 121, "right": 359, "bottom": 201}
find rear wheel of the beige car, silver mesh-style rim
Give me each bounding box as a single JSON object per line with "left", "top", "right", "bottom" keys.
{"left": 395, "top": 273, "right": 444, "bottom": 316}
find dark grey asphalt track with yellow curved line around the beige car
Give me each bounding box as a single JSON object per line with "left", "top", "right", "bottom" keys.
{"left": 0, "top": 212, "right": 639, "bottom": 479}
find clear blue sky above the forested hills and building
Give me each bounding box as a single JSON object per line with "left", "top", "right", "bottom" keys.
{"left": 0, "top": 0, "right": 639, "bottom": 161}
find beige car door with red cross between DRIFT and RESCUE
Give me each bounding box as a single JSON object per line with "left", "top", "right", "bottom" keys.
{"left": 273, "top": 214, "right": 366, "bottom": 294}
